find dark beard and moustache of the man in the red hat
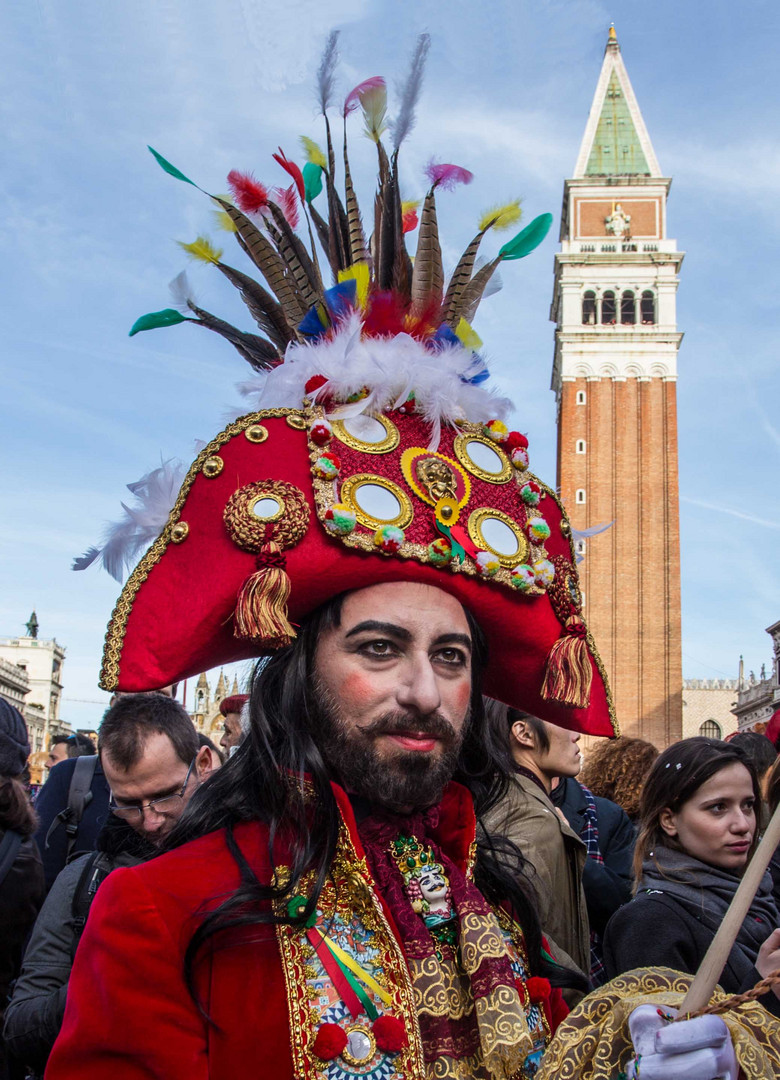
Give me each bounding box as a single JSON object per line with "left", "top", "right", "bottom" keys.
{"left": 315, "top": 680, "right": 468, "bottom": 813}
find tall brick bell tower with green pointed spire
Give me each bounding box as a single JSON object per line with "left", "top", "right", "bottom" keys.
{"left": 551, "top": 28, "right": 683, "bottom": 747}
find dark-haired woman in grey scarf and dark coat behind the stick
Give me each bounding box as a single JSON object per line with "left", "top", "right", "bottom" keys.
{"left": 604, "top": 737, "right": 780, "bottom": 1015}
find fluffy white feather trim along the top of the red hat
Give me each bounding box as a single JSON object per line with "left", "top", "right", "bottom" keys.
{"left": 239, "top": 314, "right": 512, "bottom": 449}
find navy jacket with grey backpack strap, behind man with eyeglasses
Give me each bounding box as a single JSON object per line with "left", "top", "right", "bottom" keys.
{"left": 36, "top": 757, "right": 110, "bottom": 889}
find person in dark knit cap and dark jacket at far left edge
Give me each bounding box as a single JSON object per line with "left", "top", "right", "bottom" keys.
{"left": 0, "top": 698, "right": 44, "bottom": 1080}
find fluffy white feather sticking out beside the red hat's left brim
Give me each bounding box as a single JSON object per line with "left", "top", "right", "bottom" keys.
{"left": 73, "top": 461, "right": 186, "bottom": 582}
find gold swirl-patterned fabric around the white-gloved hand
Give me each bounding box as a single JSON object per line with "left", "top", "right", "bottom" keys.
{"left": 536, "top": 968, "right": 780, "bottom": 1080}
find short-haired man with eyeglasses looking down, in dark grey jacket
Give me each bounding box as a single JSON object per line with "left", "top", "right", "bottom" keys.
{"left": 5, "top": 693, "right": 218, "bottom": 1075}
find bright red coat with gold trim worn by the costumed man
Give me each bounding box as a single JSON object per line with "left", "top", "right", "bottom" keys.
{"left": 45, "top": 784, "right": 566, "bottom": 1080}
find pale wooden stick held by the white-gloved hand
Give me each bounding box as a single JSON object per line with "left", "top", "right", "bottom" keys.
{"left": 678, "top": 806, "right": 780, "bottom": 1016}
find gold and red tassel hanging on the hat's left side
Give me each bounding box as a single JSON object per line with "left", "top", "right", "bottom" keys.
{"left": 233, "top": 541, "right": 295, "bottom": 649}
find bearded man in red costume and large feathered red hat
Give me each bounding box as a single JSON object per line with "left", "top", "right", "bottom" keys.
{"left": 48, "top": 37, "right": 760, "bottom": 1080}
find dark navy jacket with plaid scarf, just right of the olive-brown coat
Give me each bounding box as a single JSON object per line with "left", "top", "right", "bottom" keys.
{"left": 550, "top": 777, "right": 634, "bottom": 988}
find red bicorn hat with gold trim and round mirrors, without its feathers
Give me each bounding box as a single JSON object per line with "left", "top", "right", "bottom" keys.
{"left": 100, "top": 406, "right": 615, "bottom": 735}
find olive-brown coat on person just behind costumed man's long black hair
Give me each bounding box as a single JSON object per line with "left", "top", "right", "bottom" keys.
{"left": 486, "top": 774, "right": 590, "bottom": 975}
